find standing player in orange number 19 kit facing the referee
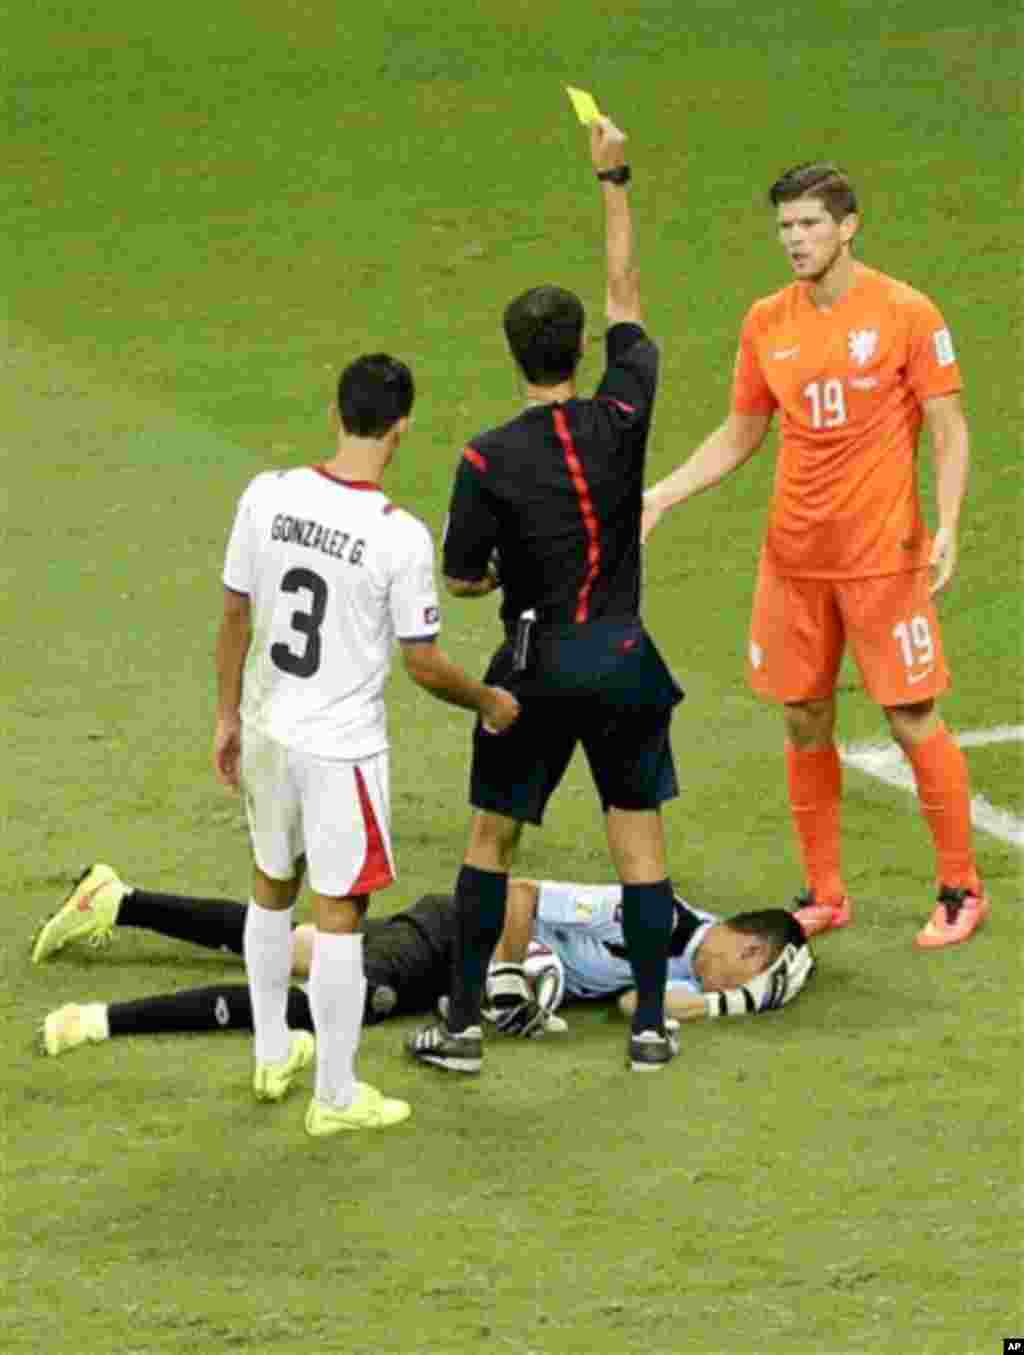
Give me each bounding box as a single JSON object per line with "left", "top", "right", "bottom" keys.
{"left": 645, "top": 164, "right": 989, "bottom": 949}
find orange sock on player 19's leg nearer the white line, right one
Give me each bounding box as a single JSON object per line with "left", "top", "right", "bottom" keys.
{"left": 903, "top": 725, "right": 978, "bottom": 890}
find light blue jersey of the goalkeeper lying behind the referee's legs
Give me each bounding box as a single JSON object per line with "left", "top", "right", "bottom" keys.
{"left": 534, "top": 881, "right": 721, "bottom": 997}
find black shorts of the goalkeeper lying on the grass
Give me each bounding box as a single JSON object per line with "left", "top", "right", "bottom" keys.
{"left": 363, "top": 894, "right": 455, "bottom": 1024}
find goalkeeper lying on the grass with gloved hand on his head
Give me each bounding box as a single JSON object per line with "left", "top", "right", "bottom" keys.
{"left": 33, "top": 866, "right": 813, "bottom": 1056}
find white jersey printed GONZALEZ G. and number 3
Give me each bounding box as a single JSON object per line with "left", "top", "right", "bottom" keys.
{"left": 223, "top": 466, "right": 440, "bottom": 759}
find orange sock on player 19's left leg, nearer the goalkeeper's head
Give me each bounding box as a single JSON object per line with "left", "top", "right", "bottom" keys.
{"left": 786, "top": 743, "right": 847, "bottom": 904}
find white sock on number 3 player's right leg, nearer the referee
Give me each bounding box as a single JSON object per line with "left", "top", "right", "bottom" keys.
{"left": 309, "top": 931, "right": 366, "bottom": 1110}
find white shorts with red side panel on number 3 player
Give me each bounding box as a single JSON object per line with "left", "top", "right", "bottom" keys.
{"left": 241, "top": 728, "right": 396, "bottom": 898}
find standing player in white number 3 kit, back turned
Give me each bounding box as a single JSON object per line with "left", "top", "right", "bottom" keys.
{"left": 214, "top": 354, "right": 519, "bottom": 1135}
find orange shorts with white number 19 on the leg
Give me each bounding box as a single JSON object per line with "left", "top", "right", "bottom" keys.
{"left": 748, "top": 557, "right": 950, "bottom": 706}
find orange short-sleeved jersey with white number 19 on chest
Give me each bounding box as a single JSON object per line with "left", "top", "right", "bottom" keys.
{"left": 733, "top": 264, "right": 960, "bottom": 579}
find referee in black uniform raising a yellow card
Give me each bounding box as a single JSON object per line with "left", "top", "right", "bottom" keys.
{"left": 408, "top": 118, "right": 683, "bottom": 1073}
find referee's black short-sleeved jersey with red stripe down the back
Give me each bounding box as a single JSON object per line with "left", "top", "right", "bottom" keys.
{"left": 443, "top": 324, "right": 658, "bottom": 630}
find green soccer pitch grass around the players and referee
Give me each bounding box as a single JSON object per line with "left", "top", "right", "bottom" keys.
{"left": 0, "top": 0, "right": 1024, "bottom": 1355}
